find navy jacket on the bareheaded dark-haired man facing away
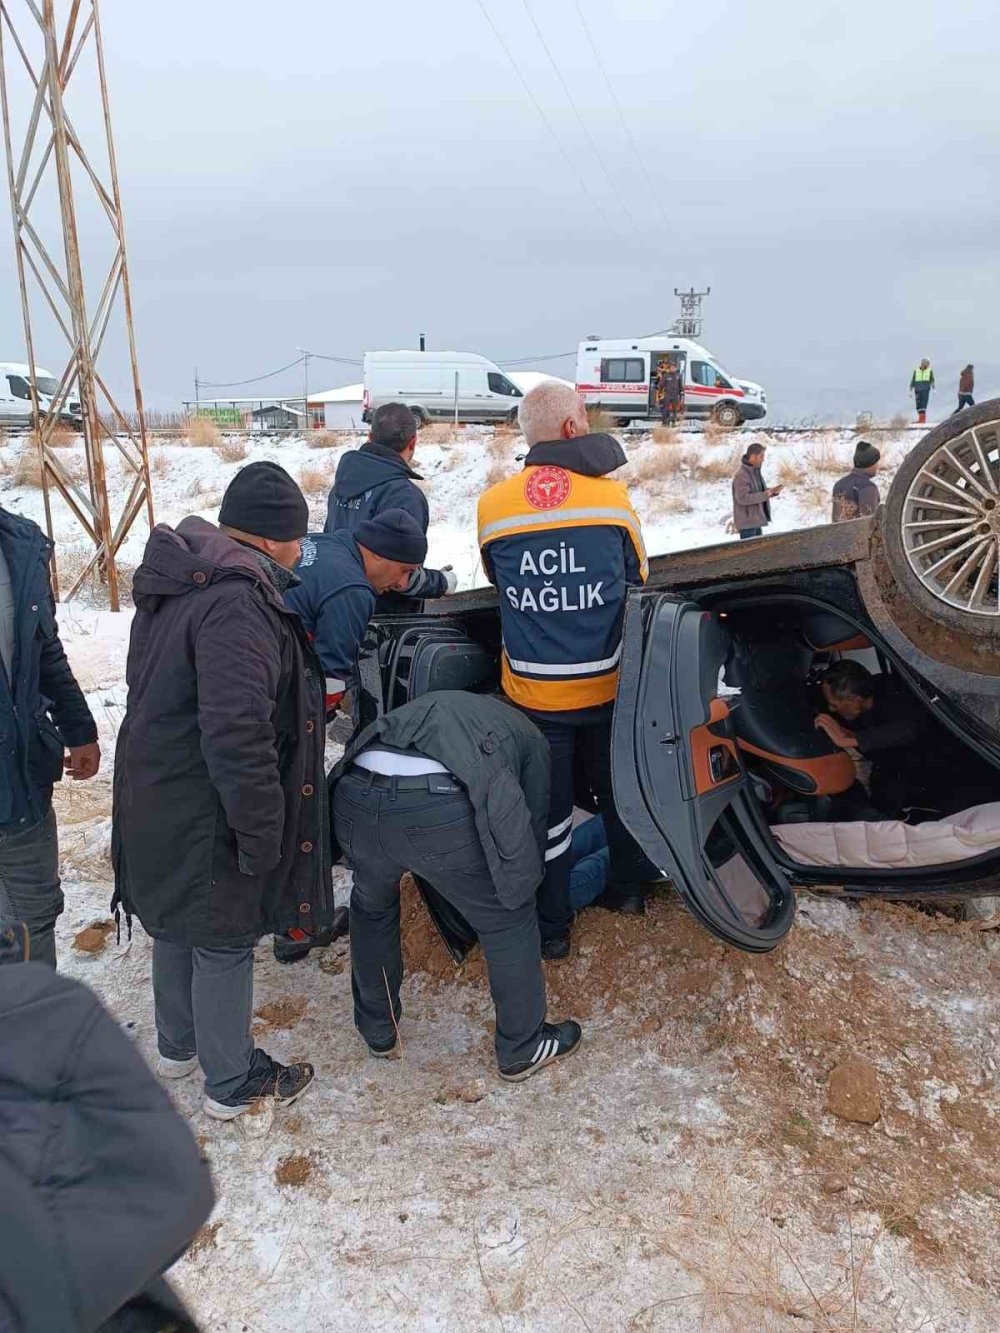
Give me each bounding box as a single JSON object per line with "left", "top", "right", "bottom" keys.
{"left": 323, "top": 440, "right": 448, "bottom": 599}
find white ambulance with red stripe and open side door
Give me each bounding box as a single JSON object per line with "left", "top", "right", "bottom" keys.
{"left": 576, "top": 333, "right": 767, "bottom": 428}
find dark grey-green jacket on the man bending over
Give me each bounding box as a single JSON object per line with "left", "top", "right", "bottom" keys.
{"left": 329, "top": 689, "right": 549, "bottom": 908}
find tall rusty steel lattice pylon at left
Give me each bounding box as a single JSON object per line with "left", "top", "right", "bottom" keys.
{"left": 0, "top": 0, "right": 153, "bottom": 611}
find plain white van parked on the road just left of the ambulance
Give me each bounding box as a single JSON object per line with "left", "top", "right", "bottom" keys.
{"left": 361, "top": 352, "right": 524, "bottom": 425}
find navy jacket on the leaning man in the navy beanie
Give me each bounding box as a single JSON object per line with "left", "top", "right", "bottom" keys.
{"left": 285, "top": 532, "right": 375, "bottom": 704}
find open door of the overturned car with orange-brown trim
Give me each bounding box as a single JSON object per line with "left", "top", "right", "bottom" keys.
{"left": 612, "top": 589, "right": 795, "bottom": 953}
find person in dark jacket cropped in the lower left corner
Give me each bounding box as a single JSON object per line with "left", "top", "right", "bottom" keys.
{"left": 0, "top": 920, "right": 213, "bottom": 1333}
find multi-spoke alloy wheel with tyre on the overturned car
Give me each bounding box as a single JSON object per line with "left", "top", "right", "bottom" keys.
{"left": 883, "top": 400, "right": 1000, "bottom": 639}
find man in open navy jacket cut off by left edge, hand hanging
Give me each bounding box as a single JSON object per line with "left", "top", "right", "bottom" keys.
{"left": 0, "top": 509, "right": 100, "bottom": 968}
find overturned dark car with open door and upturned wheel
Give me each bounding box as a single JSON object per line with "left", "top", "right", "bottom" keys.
{"left": 357, "top": 400, "right": 1000, "bottom": 950}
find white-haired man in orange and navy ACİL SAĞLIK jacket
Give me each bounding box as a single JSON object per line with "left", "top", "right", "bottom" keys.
{"left": 479, "top": 380, "right": 647, "bottom": 958}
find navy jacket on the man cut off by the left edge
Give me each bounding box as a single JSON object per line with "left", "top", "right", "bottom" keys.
{"left": 0, "top": 509, "right": 97, "bottom": 829}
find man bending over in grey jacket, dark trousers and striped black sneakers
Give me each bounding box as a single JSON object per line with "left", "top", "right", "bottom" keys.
{"left": 331, "top": 690, "right": 581, "bottom": 1082}
